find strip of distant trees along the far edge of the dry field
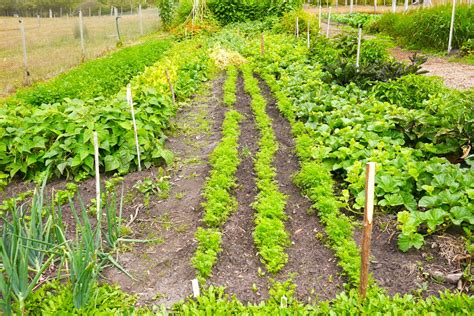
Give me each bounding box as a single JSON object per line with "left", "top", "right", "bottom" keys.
{"left": 0, "top": 0, "right": 151, "bottom": 17}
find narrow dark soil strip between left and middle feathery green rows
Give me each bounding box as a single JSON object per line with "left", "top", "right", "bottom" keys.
{"left": 209, "top": 75, "right": 269, "bottom": 303}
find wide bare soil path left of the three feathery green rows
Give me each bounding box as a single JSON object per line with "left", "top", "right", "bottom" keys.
{"left": 104, "top": 78, "right": 226, "bottom": 306}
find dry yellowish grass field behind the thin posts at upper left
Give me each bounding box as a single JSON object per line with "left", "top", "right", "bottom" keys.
{"left": 0, "top": 8, "right": 160, "bottom": 97}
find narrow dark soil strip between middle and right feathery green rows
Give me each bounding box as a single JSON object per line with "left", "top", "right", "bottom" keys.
{"left": 260, "top": 80, "right": 343, "bottom": 303}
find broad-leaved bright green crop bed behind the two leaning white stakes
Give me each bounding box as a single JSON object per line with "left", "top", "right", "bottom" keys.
{"left": 0, "top": 39, "right": 210, "bottom": 185}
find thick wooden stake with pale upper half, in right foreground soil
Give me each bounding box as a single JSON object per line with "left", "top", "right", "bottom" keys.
{"left": 359, "top": 162, "right": 375, "bottom": 298}
